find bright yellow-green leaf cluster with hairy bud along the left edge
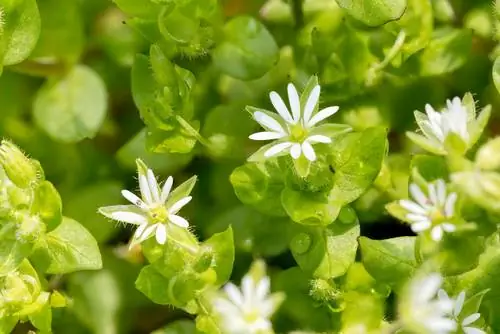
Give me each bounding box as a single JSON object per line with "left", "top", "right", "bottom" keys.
{"left": 0, "top": 141, "right": 102, "bottom": 333}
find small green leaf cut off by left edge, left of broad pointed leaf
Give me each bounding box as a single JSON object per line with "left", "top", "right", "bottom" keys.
{"left": 0, "top": 223, "right": 33, "bottom": 276}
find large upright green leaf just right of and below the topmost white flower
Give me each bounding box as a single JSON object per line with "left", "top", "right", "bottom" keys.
{"left": 329, "top": 127, "right": 387, "bottom": 206}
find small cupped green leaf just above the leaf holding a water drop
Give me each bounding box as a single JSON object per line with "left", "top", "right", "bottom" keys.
{"left": 281, "top": 188, "right": 341, "bottom": 225}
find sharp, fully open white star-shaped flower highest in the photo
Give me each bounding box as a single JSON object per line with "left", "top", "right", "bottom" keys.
{"left": 250, "top": 83, "right": 339, "bottom": 161}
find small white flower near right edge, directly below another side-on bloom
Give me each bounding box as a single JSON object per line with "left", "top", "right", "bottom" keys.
{"left": 399, "top": 180, "right": 457, "bottom": 241}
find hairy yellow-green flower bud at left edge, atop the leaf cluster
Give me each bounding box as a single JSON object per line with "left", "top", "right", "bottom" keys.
{"left": 0, "top": 140, "right": 39, "bottom": 188}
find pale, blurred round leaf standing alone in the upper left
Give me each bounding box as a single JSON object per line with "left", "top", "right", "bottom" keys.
{"left": 33, "top": 65, "right": 107, "bottom": 143}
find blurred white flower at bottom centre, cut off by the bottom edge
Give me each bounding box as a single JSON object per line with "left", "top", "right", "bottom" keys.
{"left": 213, "top": 274, "right": 281, "bottom": 334}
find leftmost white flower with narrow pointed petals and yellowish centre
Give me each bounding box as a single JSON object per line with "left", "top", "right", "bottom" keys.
{"left": 99, "top": 164, "right": 192, "bottom": 247}
